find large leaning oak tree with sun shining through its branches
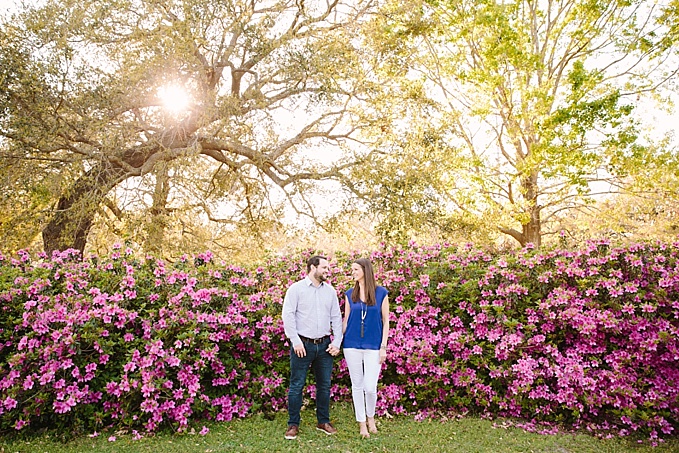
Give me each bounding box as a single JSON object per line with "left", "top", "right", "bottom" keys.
{"left": 0, "top": 0, "right": 380, "bottom": 252}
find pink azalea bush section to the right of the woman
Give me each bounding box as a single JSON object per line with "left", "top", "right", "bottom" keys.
{"left": 381, "top": 241, "right": 679, "bottom": 440}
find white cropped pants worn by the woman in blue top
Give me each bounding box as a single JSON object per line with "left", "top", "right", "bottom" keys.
{"left": 344, "top": 348, "right": 381, "bottom": 422}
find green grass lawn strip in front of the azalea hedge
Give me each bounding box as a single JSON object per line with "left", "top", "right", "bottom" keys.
{"left": 0, "top": 404, "right": 679, "bottom": 453}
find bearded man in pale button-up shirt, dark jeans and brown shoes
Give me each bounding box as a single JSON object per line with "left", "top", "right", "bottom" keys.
{"left": 283, "top": 256, "right": 342, "bottom": 439}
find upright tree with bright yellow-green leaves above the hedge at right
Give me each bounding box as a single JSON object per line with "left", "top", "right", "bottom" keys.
{"left": 356, "top": 0, "right": 677, "bottom": 245}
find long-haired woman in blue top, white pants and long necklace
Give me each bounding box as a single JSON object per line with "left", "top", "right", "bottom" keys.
{"left": 343, "top": 258, "right": 389, "bottom": 437}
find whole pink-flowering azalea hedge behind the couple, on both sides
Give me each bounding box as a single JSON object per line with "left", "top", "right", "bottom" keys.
{"left": 0, "top": 241, "right": 679, "bottom": 441}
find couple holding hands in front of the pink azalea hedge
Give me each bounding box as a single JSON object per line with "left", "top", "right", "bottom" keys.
{"left": 283, "top": 255, "right": 389, "bottom": 439}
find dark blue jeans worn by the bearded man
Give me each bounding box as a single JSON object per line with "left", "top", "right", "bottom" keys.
{"left": 288, "top": 338, "right": 333, "bottom": 426}
